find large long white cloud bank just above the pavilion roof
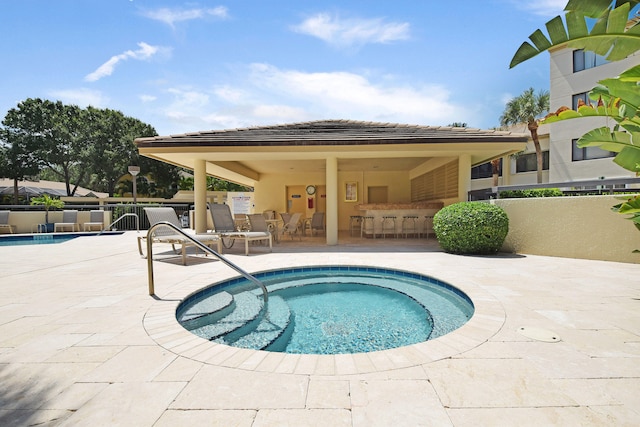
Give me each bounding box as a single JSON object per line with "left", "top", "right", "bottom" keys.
{"left": 151, "top": 64, "right": 470, "bottom": 133}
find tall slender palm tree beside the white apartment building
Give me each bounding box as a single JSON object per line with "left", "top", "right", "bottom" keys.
{"left": 500, "top": 88, "right": 549, "bottom": 184}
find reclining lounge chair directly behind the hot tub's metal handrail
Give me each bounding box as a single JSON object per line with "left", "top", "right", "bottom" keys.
{"left": 138, "top": 207, "right": 222, "bottom": 265}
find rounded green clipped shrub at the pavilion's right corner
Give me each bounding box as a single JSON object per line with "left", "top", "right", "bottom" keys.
{"left": 433, "top": 202, "right": 509, "bottom": 254}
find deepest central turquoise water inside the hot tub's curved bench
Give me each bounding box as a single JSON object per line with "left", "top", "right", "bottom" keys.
{"left": 274, "top": 283, "right": 433, "bottom": 354}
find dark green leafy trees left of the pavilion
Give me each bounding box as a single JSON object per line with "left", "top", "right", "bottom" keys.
{"left": 0, "top": 98, "right": 179, "bottom": 202}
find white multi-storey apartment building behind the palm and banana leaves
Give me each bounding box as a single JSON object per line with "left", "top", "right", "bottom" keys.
{"left": 471, "top": 47, "right": 640, "bottom": 190}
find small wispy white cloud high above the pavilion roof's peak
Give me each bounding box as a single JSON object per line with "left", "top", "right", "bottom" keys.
{"left": 292, "top": 13, "right": 410, "bottom": 46}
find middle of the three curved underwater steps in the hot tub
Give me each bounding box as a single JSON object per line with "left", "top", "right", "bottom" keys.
{"left": 188, "top": 292, "right": 263, "bottom": 341}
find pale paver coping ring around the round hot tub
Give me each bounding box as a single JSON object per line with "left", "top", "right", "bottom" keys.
{"left": 143, "top": 262, "right": 506, "bottom": 376}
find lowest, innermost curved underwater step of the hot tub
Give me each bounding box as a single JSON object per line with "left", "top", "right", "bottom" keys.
{"left": 217, "top": 296, "right": 291, "bottom": 350}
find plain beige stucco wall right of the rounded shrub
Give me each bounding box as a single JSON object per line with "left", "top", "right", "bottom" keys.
{"left": 492, "top": 196, "right": 640, "bottom": 263}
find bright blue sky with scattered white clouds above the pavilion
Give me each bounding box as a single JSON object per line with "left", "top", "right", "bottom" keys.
{"left": 0, "top": 0, "right": 567, "bottom": 135}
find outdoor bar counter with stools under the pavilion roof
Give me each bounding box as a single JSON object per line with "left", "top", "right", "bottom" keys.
{"left": 356, "top": 202, "right": 444, "bottom": 237}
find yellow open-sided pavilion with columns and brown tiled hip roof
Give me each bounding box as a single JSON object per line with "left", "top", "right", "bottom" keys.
{"left": 135, "top": 120, "right": 527, "bottom": 245}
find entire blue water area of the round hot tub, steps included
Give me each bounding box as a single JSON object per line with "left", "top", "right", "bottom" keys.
{"left": 176, "top": 266, "right": 473, "bottom": 354}
